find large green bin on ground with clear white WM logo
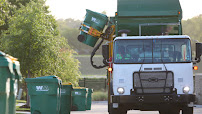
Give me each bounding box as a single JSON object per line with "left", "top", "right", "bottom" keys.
{"left": 25, "top": 76, "right": 62, "bottom": 114}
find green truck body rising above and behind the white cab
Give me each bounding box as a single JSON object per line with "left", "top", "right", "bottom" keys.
{"left": 115, "top": 0, "right": 182, "bottom": 36}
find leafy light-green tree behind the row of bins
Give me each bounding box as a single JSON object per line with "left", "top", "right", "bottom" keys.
{"left": 1, "top": 0, "right": 80, "bottom": 84}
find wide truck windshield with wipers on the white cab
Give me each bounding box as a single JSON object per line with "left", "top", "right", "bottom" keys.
{"left": 114, "top": 39, "right": 191, "bottom": 64}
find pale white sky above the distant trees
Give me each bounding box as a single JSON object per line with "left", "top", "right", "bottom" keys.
{"left": 46, "top": 0, "right": 202, "bottom": 20}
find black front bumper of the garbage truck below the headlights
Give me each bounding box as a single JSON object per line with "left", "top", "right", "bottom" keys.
{"left": 111, "top": 94, "right": 195, "bottom": 104}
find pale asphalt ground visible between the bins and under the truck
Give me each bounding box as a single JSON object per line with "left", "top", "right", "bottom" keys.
{"left": 16, "top": 101, "right": 202, "bottom": 114}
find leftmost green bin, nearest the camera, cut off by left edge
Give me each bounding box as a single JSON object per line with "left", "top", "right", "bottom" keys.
{"left": 0, "top": 51, "right": 14, "bottom": 114}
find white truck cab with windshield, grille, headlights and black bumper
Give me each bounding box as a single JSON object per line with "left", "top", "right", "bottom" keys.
{"left": 111, "top": 35, "right": 195, "bottom": 114}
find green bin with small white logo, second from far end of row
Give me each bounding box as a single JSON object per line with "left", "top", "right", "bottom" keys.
{"left": 72, "top": 87, "right": 88, "bottom": 111}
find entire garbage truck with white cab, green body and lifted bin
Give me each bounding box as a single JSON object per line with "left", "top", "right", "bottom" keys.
{"left": 78, "top": 0, "right": 202, "bottom": 114}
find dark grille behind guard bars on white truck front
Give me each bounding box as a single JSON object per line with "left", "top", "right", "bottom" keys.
{"left": 133, "top": 71, "right": 174, "bottom": 94}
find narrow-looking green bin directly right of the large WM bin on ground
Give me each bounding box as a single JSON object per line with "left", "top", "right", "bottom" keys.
{"left": 60, "top": 83, "right": 73, "bottom": 114}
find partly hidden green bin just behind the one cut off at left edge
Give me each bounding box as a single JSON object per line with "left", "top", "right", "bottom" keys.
{"left": 9, "top": 58, "right": 22, "bottom": 114}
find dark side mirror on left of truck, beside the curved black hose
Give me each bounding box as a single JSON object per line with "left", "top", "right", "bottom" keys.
{"left": 102, "top": 44, "right": 109, "bottom": 66}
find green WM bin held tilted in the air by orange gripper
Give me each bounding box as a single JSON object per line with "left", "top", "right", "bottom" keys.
{"left": 78, "top": 9, "right": 108, "bottom": 47}
